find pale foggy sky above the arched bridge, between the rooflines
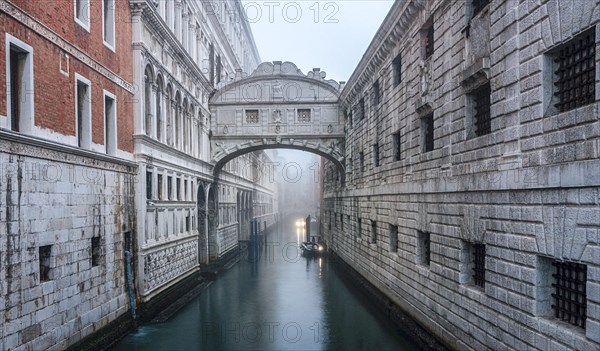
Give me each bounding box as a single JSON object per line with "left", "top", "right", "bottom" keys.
{"left": 242, "top": 0, "right": 393, "bottom": 81}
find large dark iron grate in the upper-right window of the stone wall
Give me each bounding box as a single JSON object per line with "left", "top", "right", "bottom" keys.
{"left": 554, "top": 30, "right": 596, "bottom": 112}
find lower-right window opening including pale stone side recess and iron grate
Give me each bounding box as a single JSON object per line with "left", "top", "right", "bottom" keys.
{"left": 536, "top": 257, "right": 587, "bottom": 329}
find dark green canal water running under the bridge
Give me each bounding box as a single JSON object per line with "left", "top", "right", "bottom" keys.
{"left": 114, "top": 221, "right": 418, "bottom": 351}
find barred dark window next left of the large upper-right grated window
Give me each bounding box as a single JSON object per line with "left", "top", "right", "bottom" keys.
{"left": 467, "top": 81, "right": 492, "bottom": 136}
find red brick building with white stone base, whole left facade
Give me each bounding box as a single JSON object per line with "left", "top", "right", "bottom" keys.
{"left": 0, "top": 0, "right": 137, "bottom": 350}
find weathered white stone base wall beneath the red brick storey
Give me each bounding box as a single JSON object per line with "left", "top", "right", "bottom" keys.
{"left": 0, "top": 132, "right": 135, "bottom": 350}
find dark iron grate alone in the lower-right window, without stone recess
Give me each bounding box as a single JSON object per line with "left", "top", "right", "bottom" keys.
{"left": 552, "top": 262, "right": 587, "bottom": 329}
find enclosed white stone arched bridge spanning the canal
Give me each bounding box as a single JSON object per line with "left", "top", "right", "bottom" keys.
{"left": 210, "top": 61, "right": 344, "bottom": 177}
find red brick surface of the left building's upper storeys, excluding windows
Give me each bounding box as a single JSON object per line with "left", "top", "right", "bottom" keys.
{"left": 0, "top": 0, "right": 133, "bottom": 152}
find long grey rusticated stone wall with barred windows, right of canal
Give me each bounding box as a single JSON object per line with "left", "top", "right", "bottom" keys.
{"left": 323, "top": 1, "right": 600, "bottom": 350}
